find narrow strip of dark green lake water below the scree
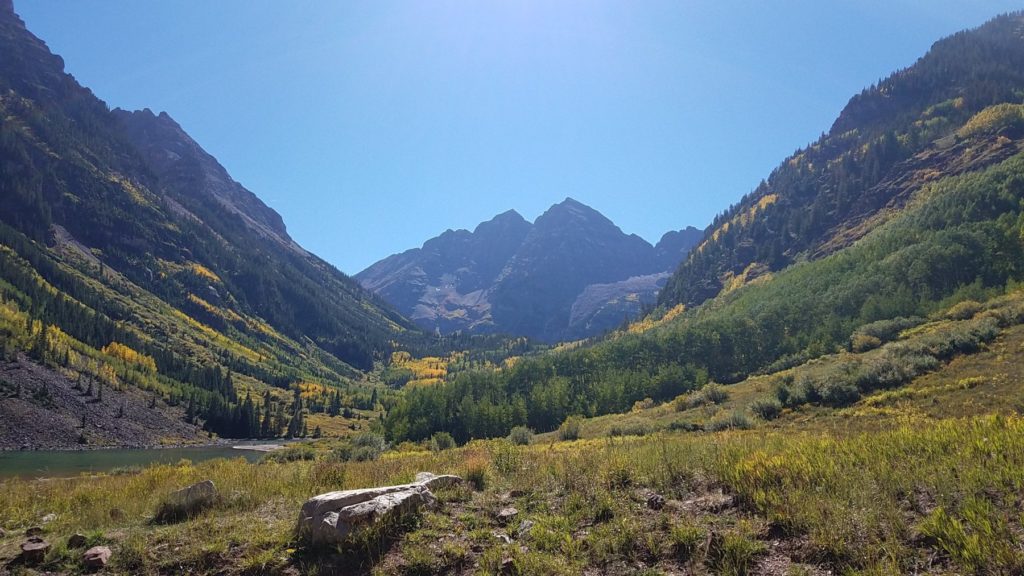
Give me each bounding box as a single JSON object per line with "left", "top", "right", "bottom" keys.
{"left": 0, "top": 443, "right": 274, "bottom": 480}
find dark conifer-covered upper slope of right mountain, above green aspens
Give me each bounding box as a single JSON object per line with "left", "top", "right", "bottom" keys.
{"left": 660, "top": 13, "right": 1024, "bottom": 306}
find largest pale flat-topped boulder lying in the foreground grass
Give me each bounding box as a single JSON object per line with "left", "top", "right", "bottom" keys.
{"left": 296, "top": 472, "right": 462, "bottom": 546}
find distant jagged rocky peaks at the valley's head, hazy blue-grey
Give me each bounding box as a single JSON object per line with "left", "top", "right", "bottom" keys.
{"left": 355, "top": 198, "right": 702, "bottom": 341}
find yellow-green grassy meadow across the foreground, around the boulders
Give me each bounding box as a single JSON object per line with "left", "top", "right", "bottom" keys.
{"left": 0, "top": 407, "right": 1024, "bottom": 574}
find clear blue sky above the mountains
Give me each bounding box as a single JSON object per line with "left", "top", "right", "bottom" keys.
{"left": 15, "top": 0, "right": 1024, "bottom": 274}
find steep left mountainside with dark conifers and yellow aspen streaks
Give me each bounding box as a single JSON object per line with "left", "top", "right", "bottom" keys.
{"left": 0, "top": 2, "right": 417, "bottom": 443}
